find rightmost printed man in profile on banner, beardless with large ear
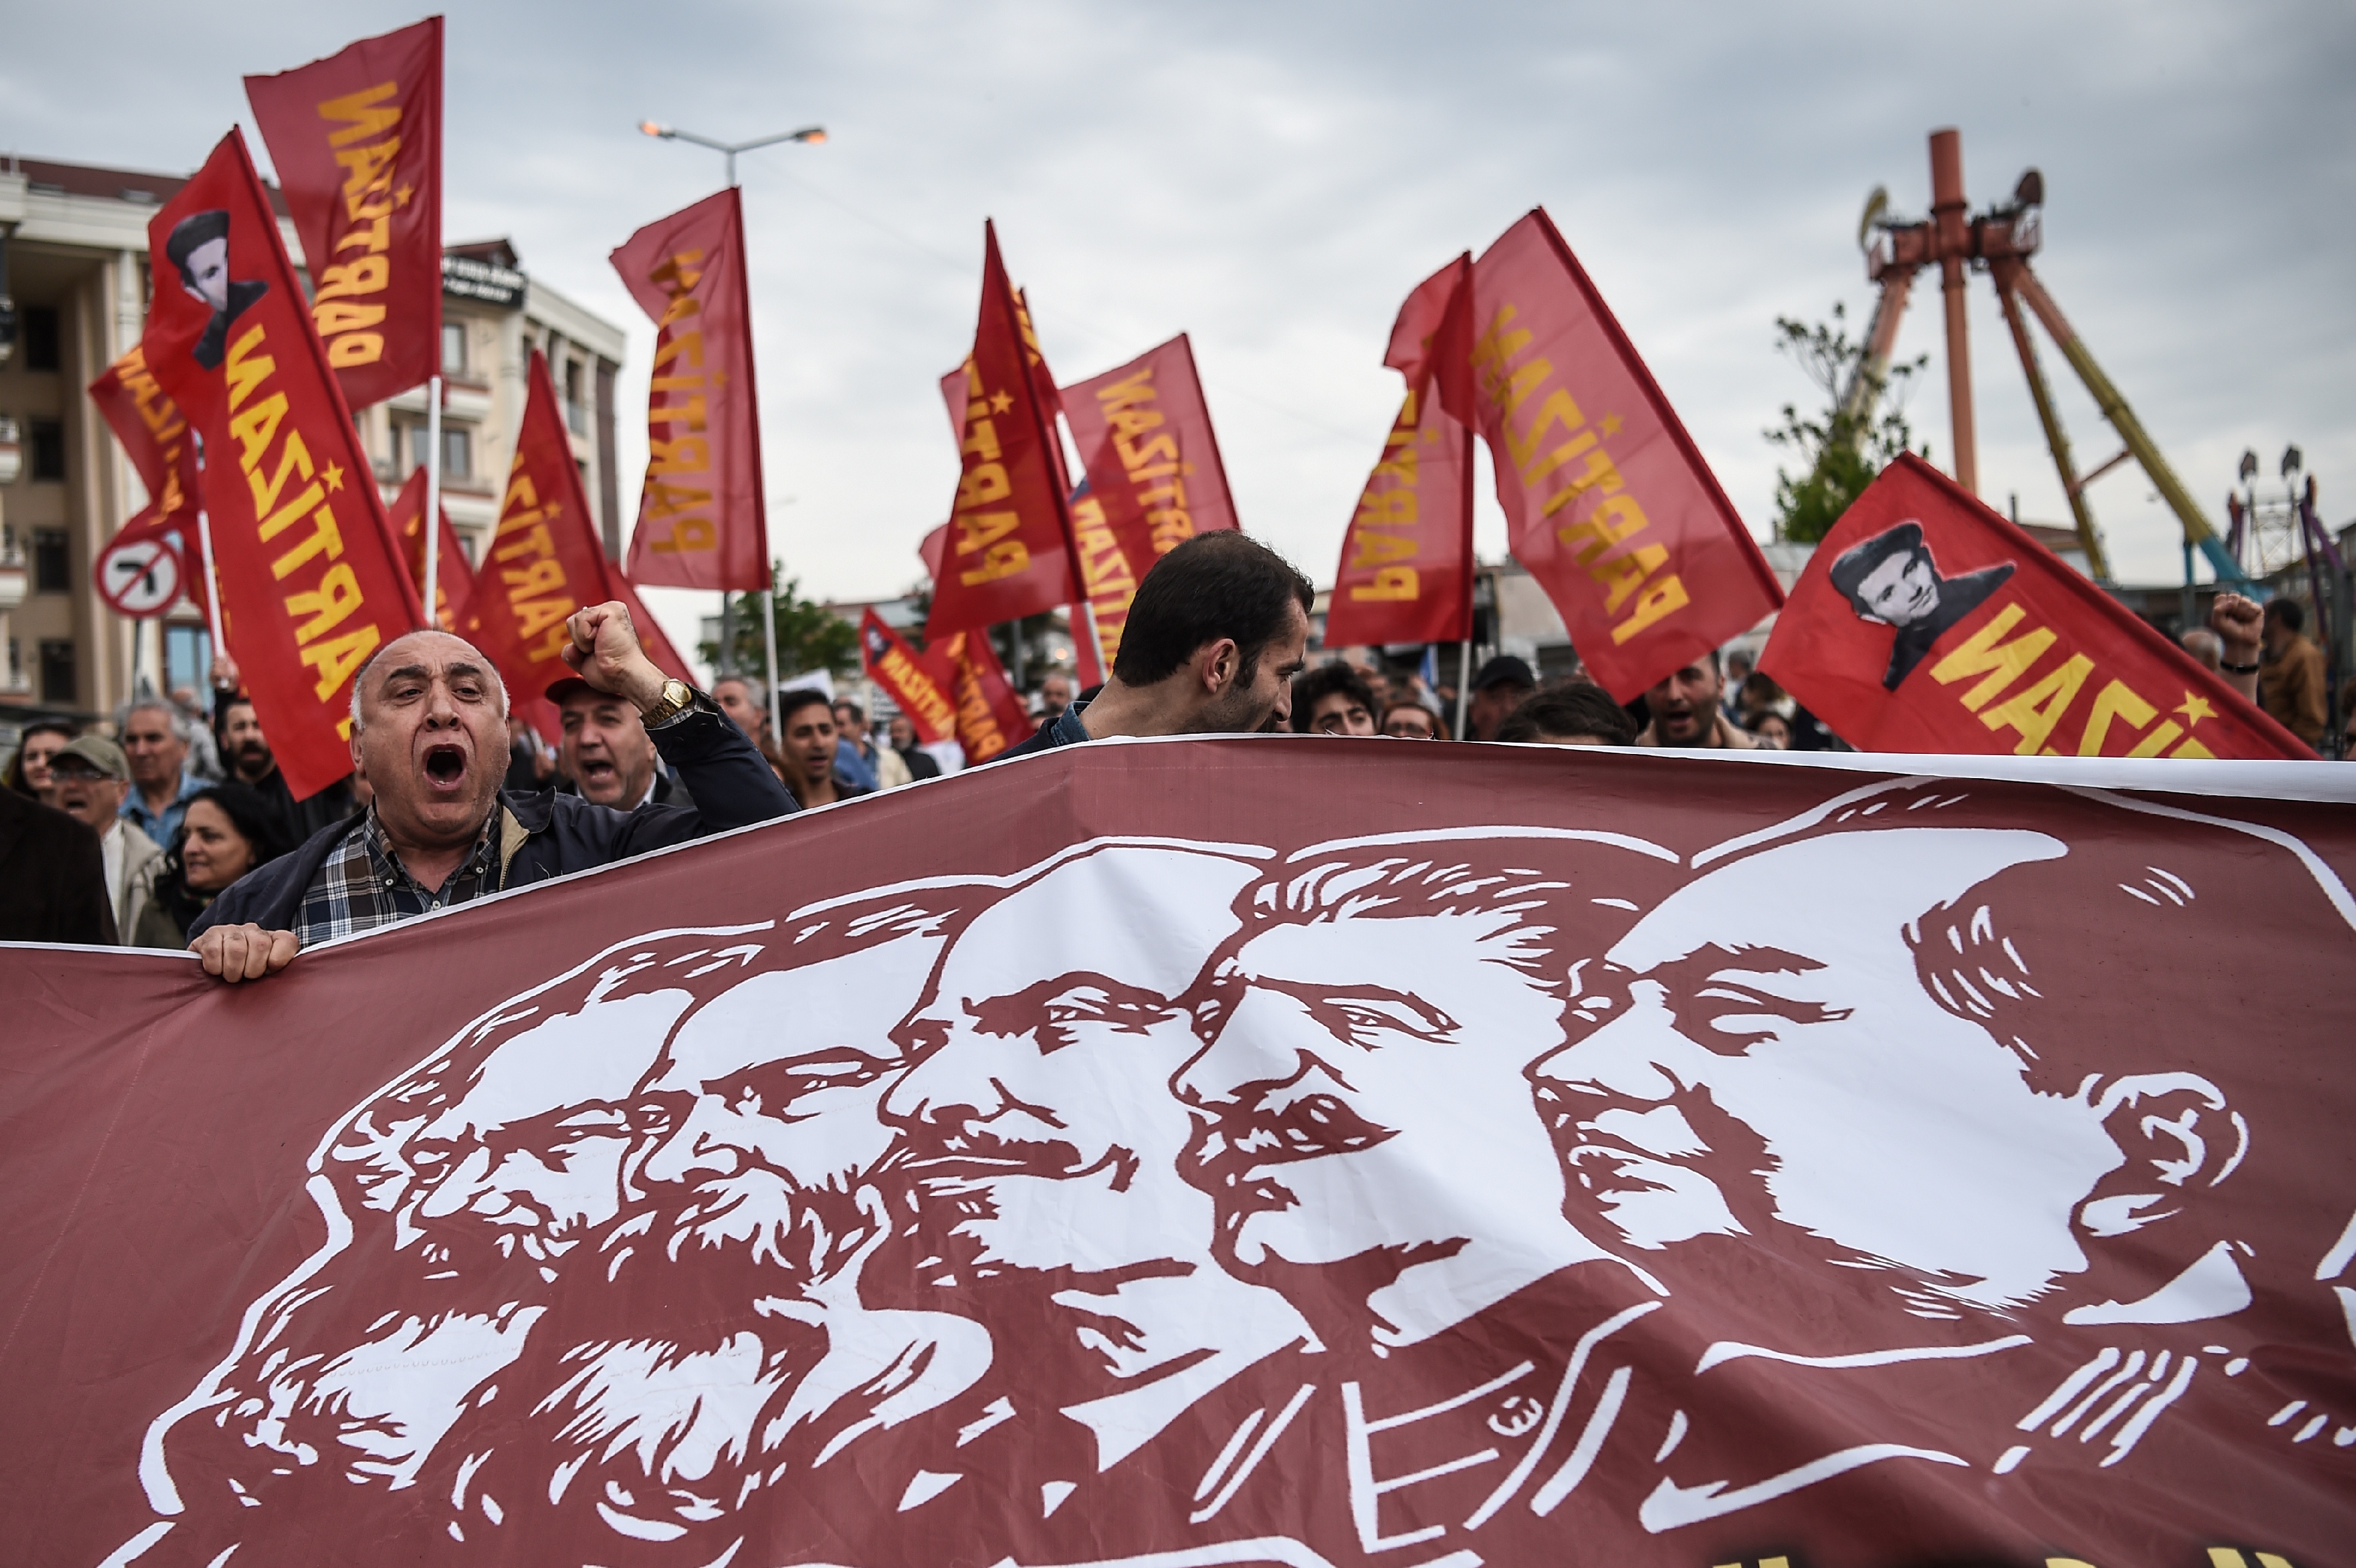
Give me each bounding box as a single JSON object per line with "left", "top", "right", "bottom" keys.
{"left": 1536, "top": 782, "right": 2356, "bottom": 1563}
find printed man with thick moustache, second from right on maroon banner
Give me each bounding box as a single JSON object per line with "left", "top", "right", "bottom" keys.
{"left": 1176, "top": 829, "right": 1675, "bottom": 1559}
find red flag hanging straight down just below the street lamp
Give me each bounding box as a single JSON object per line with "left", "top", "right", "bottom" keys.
{"left": 613, "top": 186, "right": 768, "bottom": 593}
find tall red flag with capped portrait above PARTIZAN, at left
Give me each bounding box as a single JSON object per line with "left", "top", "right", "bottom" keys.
{"left": 144, "top": 132, "right": 422, "bottom": 798}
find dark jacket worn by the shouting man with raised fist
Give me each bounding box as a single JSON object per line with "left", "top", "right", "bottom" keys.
{"left": 188, "top": 706, "right": 799, "bottom": 942}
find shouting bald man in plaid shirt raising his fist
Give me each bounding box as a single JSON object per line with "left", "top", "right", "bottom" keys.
{"left": 188, "top": 603, "right": 794, "bottom": 982}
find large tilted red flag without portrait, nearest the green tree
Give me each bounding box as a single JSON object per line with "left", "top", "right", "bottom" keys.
{"left": 1435, "top": 207, "right": 1783, "bottom": 702}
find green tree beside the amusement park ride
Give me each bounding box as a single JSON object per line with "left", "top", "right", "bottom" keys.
{"left": 1765, "top": 302, "right": 1930, "bottom": 544}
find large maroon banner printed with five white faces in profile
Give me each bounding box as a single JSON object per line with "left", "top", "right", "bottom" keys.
{"left": 0, "top": 737, "right": 2356, "bottom": 1568}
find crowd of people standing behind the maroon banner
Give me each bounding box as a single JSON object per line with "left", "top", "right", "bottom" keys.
{"left": 0, "top": 532, "right": 2328, "bottom": 960}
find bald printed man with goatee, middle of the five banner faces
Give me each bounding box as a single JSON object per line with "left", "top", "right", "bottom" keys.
{"left": 867, "top": 841, "right": 1308, "bottom": 1563}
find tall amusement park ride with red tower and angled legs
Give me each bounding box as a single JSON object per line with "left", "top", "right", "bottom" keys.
{"left": 1842, "top": 130, "right": 2250, "bottom": 588}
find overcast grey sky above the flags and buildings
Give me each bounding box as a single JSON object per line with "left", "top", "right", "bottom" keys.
{"left": 0, "top": 0, "right": 2356, "bottom": 654}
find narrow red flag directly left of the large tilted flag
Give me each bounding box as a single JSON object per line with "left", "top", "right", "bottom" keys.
{"left": 1324, "top": 257, "right": 1472, "bottom": 647}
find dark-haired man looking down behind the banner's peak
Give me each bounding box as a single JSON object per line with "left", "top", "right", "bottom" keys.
{"left": 992, "top": 530, "right": 1317, "bottom": 763}
